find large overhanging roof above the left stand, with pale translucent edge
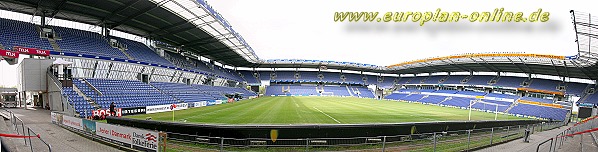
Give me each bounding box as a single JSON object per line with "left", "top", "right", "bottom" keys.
{"left": 0, "top": 0, "right": 258, "bottom": 66}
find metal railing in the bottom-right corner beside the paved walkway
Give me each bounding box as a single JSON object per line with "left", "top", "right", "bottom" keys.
{"left": 536, "top": 116, "right": 598, "bottom": 152}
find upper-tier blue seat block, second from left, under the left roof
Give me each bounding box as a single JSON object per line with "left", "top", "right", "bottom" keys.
{"left": 52, "top": 26, "right": 127, "bottom": 59}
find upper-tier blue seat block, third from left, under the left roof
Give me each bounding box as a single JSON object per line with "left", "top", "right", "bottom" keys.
{"left": 114, "top": 37, "right": 174, "bottom": 67}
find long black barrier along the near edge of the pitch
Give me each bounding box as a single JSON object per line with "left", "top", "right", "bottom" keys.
{"left": 107, "top": 117, "right": 547, "bottom": 142}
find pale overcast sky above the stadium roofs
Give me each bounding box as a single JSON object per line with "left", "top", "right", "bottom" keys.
{"left": 0, "top": 0, "right": 598, "bottom": 86}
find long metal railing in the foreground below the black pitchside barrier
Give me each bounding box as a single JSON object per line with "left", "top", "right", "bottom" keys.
{"left": 165, "top": 122, "right": 563, "bottom": 151}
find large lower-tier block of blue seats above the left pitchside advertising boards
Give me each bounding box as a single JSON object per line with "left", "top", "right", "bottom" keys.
{"left": 86, "top": 79, "right": 178, "bottom": 108}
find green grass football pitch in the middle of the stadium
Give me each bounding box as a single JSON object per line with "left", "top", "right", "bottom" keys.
{"left": 127, "top": 97, "right": 527, "bottom": 125}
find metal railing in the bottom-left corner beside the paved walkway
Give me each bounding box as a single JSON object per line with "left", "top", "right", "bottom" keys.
{"left": 2, "top": 108, "right": 52, "bottom": 152}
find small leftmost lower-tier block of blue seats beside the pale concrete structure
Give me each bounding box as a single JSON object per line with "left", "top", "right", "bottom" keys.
{"left": 62, "top": 87, "right": 94, "bottom": 117}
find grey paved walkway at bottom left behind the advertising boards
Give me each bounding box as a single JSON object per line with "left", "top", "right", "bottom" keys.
{"left": 3, "top": 109, "right": 120, "bottom": 152}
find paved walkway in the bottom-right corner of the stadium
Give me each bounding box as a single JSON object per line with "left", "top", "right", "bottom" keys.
{"left": 479, "top": 125, "right": 598, "bottom": 152}
